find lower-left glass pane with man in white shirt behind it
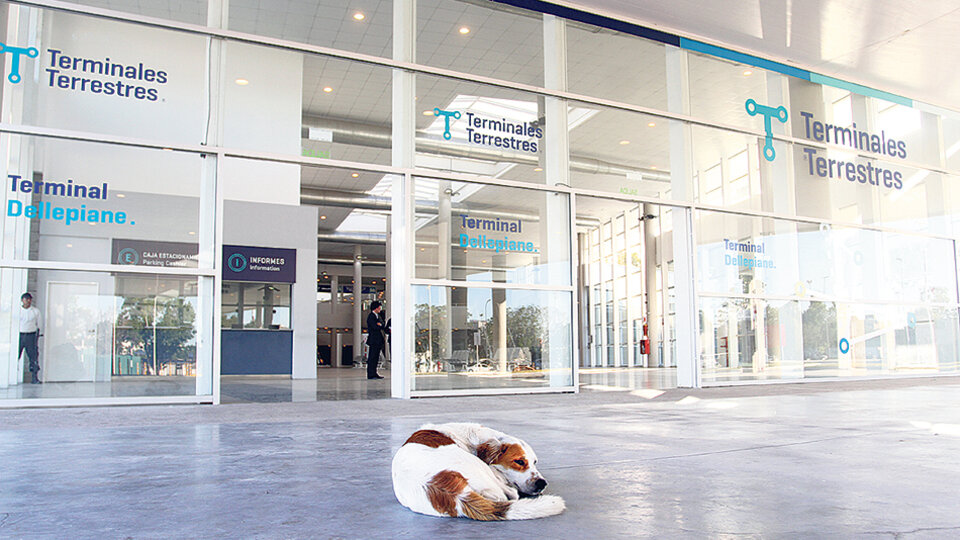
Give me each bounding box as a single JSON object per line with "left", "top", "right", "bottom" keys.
{"left": 0, "top": 268, "right": 210, "bottom": 399}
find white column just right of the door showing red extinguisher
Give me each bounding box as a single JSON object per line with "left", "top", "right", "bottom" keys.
{"left": 666, "top": 45, "right": 700, "bottom": 388}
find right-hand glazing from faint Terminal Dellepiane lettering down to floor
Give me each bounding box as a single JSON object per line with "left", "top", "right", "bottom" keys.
{"left": 696, "top": 211, "right": 958, "bottom": 384}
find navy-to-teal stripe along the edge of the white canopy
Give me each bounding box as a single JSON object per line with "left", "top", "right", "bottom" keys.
{"left": 489, "top": 0, "right": 913, "bottom": 107}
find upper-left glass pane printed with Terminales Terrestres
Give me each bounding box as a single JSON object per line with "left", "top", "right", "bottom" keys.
{"left": 0, "top": 1, "right": 210, "bottom": 145}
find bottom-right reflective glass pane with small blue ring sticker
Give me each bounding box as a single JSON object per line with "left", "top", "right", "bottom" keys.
{"left": 699, "top": 298, "right": 960, "bottom": 384}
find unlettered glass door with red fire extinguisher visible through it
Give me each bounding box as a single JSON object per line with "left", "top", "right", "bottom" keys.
{"left": 576, "top": 196, "right": 677, "bottom": 390}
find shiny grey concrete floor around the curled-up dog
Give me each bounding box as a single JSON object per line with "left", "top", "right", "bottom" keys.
{"left": 0, "top": 377, "right": 960, "bottom": 538}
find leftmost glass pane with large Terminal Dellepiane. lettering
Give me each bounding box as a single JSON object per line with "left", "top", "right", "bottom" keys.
{"left": 0, "top": 134, "right": 206, "bottom": 268}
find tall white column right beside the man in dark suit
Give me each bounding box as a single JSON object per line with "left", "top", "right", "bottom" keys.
{"left": 388, "top": 0, "right": 417, "bottom": 398}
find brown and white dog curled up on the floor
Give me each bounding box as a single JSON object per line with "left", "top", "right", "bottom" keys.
{"left": 393, "top": 423, "right": 566, "bottom": 521}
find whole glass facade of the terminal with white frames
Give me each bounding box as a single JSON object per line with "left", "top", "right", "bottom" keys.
{"left": 0, "top": 0, "right": 960, "bottom": 405}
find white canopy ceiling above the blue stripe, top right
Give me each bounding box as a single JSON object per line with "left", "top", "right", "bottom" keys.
{"left": 554, "top": 0, "right": 960, "bottom": 110}
